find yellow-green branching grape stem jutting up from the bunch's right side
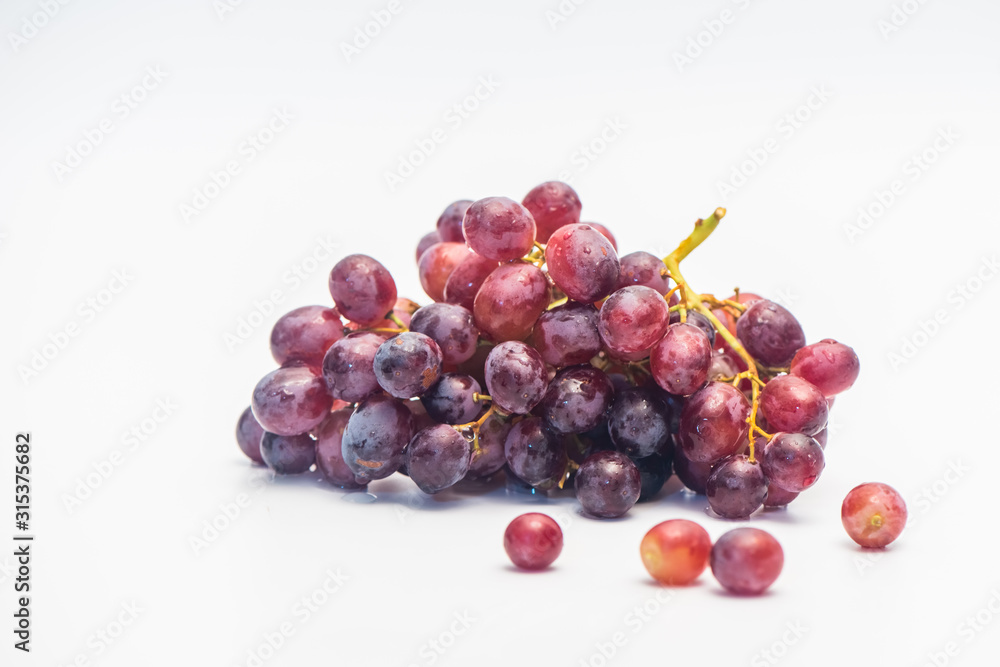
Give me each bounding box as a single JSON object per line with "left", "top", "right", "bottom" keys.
{"left": 663, "top": 207, "right": 770, "bottom": 463}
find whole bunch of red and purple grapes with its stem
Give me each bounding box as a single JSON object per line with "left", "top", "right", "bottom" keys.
{"left": 237, "top": 181, "right": 860, "bottom": 519}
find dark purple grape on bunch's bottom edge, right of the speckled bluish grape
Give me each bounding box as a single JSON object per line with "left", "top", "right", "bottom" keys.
{"left": 404, "top": 424, "right": 472, "bottom": 493}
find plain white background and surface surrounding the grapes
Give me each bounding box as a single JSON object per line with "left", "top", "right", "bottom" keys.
{"left": 0, "top": 0, "right": 1000, "bottom": 667}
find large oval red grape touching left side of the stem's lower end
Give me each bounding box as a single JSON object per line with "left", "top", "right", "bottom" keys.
{"left": 678, "top": 382, "right": 750, "bottom": 463}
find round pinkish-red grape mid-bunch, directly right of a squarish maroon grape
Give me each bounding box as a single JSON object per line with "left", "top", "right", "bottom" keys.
{"left": 597, "top": 285, "right": 669, "bottom": 354}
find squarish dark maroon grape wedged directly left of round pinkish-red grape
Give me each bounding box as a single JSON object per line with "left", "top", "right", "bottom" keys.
{"left": 531, "top": 301, "right": 602, "bottom": 368}
